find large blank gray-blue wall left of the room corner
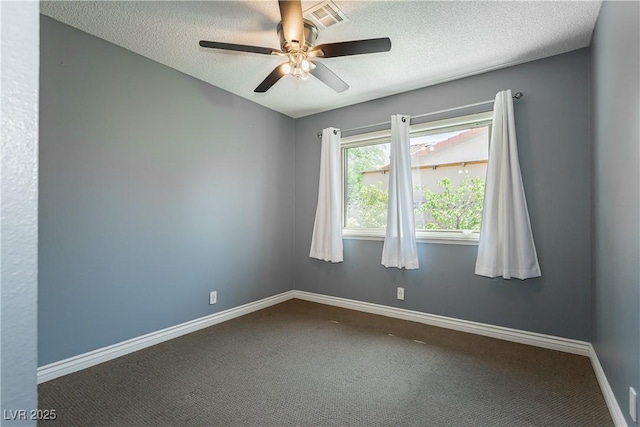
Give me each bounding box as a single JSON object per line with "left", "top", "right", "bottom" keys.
{"left": 38, "top": 17, "right": 294, "bottom": 366}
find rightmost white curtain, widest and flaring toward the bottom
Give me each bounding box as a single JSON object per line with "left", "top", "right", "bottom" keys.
{"left": 475, "top": 90, "right": 541, "bottom": 280}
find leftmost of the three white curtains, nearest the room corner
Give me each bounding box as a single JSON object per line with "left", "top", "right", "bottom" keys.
{"left": 309, "top": 128, "right": 342, "bottom": 262}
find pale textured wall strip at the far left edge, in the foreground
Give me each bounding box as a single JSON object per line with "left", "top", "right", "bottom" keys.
{"left": 0, "top": 2, "right": 39, "bottom": 426}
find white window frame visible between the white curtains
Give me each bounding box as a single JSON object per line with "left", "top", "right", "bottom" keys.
{"left": 340, "top": 111, "right": 493, "bottom": 245}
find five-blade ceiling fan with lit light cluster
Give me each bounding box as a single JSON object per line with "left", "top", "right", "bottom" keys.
{"left": 200, "top": 0, "right": 391, "bottom": 93}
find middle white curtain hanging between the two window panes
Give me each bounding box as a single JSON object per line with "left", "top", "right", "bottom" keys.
{"left": 382, "top": 115, "right": 418, "bottom": 270}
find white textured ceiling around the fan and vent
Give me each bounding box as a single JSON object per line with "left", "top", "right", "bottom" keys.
{"left": 41, "top": 0, "right": 601, "bottom": 118}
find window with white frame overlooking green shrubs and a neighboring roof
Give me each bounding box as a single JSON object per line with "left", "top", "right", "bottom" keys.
{"left": 341, "top": 112, "right": 492, "bottom": 242}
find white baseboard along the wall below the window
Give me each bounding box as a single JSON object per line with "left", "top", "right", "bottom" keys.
{"left": 293, "top": 291, "right": 591, "bottom": 356}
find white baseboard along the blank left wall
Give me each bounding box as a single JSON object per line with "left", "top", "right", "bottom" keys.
{"left": 37, "top": 291, "right": 294, "bottom": 384}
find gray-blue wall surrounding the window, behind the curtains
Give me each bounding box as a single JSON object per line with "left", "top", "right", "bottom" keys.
{"left": 295, "top": 49, "right": 591, "bottom": 341}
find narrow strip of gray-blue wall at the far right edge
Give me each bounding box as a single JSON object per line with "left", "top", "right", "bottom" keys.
{"left": 592, "top": 2, "right": 640, "bottom": 425}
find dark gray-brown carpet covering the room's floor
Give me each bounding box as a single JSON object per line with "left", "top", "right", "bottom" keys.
{"left": 38, "top": 300, "right": 613, "bottom": 427}
